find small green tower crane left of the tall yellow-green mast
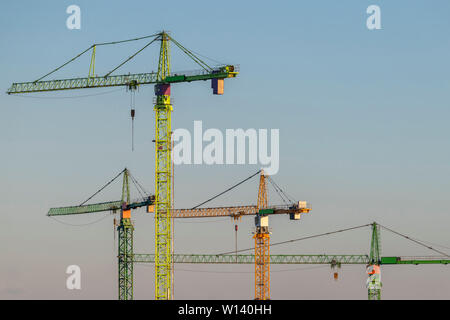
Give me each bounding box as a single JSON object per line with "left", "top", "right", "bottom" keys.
{"left": 47, "top": 168, "right": 155, "bottom": 300}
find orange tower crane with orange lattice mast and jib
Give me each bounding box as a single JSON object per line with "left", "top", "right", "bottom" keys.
{"left": 147, "top": 170, "right": 311, "bottom": 300}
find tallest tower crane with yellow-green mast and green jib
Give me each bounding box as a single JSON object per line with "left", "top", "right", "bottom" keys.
{"left": 7, "top": 31, "right": 239, "bottom": 300}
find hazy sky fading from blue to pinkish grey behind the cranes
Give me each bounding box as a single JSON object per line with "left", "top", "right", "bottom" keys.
{"left": 0, "top": 0, "right": 450, "bottom": 299}
